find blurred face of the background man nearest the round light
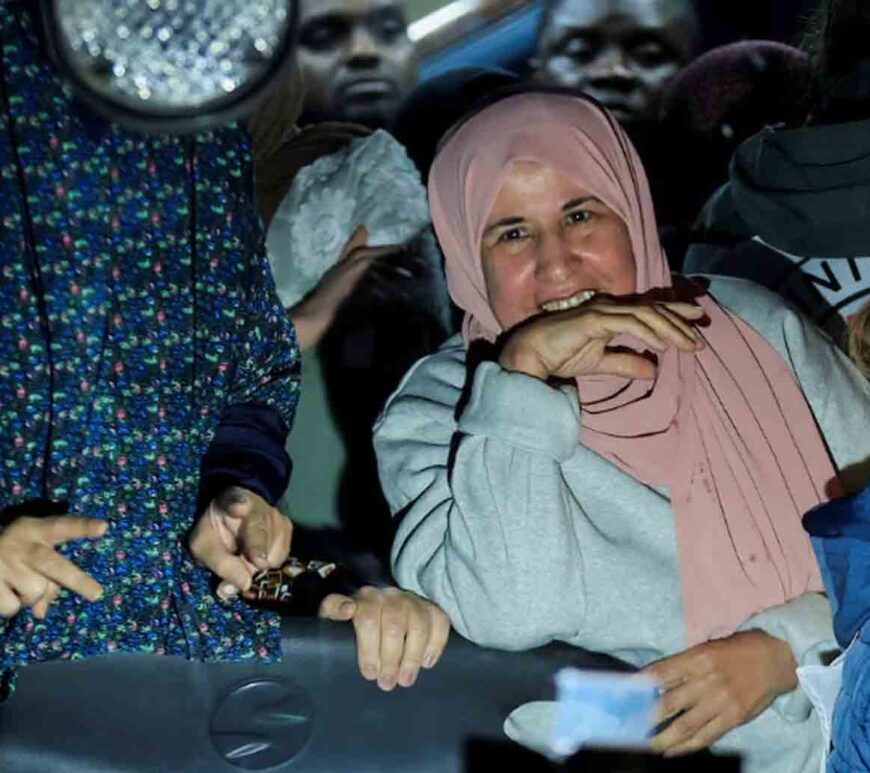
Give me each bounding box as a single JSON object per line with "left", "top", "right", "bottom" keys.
{"left": 297, "top": 0, "right": 417, "bottom": 128}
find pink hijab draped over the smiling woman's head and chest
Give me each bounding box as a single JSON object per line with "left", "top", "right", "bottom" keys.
{"left": 429, "top": 93, "right": 836, "bottom": 646}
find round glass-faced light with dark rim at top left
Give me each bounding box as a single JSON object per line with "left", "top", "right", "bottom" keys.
{"left": 40, "top": 0, "right": 298, "bottom": 133}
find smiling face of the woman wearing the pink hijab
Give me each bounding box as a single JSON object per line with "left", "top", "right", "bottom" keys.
{"left": 480, "top": 161, "right": 636, "bottom": 329}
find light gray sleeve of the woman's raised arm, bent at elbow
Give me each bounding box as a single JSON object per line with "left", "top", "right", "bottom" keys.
{"left": 374, "top": 340, "right": 585, "bottom": 649}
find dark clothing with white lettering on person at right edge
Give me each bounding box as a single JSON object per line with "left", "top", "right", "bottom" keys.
{"left": 685, "top": 120, "right": 870, "bottom": 341}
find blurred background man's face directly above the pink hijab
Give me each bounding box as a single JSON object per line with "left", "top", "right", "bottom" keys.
{"left": 536, "top": 0, "right": 697, "bottom": 128}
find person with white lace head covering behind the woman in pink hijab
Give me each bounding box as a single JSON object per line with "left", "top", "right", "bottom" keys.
{"left": 257, "top": 123, "right": 450, "bottom": 558}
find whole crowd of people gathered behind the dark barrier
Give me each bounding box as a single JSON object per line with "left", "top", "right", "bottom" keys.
{"left": 0, "top": 0, "right": 870, "bottom": 773}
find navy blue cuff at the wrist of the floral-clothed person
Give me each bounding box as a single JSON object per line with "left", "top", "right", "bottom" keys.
{"left": 199, "top": 403, "right": 292, "bottom": 511}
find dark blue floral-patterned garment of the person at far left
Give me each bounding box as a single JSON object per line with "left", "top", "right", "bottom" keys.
{"left": 0, "top": 0, "right": 300, "bottom": 692}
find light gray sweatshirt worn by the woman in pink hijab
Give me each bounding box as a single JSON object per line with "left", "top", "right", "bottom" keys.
{"left": 374, "top": 277, "right": 870, "bottom": 773}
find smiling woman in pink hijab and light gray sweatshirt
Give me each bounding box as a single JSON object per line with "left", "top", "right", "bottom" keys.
{"left": 375, "top": 93, "right": 870, "bottom": 773}
